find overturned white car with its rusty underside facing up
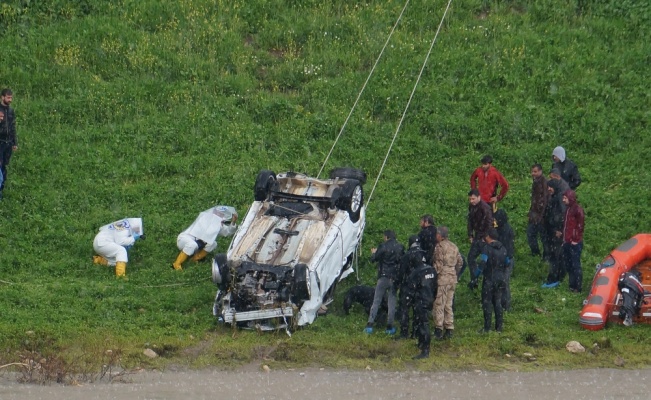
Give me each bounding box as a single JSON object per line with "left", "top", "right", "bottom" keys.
{"left": 212, "top": 168, "right": 366, "bottom": 330}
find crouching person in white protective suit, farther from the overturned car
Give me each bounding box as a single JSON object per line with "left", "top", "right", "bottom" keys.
{"left": 93, "top": 218, "right": 145, "bottom": 277}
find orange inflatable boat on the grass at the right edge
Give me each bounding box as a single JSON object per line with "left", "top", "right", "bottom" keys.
{"left": 579, "top": 233, "right": 651, "bottom": 331}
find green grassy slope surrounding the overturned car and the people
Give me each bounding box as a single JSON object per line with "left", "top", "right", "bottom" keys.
{"left": 0, "top": 0, "right": 651, "bottom": 369}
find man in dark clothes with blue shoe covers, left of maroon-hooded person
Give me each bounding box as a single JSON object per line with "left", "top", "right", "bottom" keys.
{"left": 542, "top": 179, "right": 565, "bottom": 288}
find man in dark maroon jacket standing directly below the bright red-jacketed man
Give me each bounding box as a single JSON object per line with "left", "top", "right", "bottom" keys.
{"left": 468, "top": 189, "right": 493, "bottom": 282}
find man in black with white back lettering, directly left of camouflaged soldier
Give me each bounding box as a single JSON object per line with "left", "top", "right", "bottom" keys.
{"left": 407, "top": 253, "right": 437, "bottom": 360}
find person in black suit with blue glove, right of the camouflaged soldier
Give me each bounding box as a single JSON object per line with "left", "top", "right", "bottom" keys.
{"left": 473, "top": 228, "right": 506, "bottom": 333}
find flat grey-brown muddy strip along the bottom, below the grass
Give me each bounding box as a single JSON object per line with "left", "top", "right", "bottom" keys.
{"left": 0, "top": 367, "right": 651, "bottom": 400}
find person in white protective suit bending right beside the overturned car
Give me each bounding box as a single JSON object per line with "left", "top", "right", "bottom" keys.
{"left": 172, "top": 206, "right": 237, "bottom": 270}
